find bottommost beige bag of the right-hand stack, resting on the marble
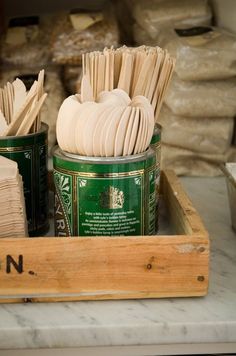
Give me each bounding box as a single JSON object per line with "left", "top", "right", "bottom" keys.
{"left": 161, "top": 144, "right": 236, "bottom": 177}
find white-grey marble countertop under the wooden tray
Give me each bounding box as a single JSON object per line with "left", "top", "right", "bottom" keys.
{"left": 0, "top": 178, "right": 236, "bottom": 349}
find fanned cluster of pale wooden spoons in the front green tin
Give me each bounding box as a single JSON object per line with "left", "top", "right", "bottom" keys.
{"left": 57, "top": 85, "right": 155, "bottom": 157}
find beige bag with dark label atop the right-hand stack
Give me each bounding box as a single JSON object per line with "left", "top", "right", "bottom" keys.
{"left": 158, "top": 26, "right": 236, "bottom": 80}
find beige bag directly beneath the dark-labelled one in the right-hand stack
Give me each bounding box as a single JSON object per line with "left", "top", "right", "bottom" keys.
{"left": 165, "top": 75, "right": 236, "bottom": 118}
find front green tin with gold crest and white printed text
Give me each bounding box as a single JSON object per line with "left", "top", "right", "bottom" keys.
{"left": 53, "top": 147, "right": 157, "bottom": 236}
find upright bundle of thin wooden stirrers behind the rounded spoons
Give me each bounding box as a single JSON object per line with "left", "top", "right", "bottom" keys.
{"left": 82, "top": 46, "right": 175, "bottom": 120}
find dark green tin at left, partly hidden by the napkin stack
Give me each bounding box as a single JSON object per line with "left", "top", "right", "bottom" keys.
{"left": 0, "top": 124, "right": 49, "bottom": 236}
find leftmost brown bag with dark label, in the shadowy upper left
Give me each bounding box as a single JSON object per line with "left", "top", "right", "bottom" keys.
{"left": 1, "top": 15, "right": 54, "bottom": 68}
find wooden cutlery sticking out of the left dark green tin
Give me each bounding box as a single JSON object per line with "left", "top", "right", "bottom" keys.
{"left": 0, "top": 70, "right": 47, "bottom": 136}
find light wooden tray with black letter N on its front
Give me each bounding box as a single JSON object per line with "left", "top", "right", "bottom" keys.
{"left": 0, "top": 171, "right": 209, "bottom": 303}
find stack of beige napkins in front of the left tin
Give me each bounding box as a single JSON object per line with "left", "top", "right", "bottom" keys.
{"left": 0, "top": 156, "right": 28, "bottom": 237}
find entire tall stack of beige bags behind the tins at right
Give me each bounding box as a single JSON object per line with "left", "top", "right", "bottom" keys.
{"left": 125, "top": 0, "right": 236, "bottom": 176}
